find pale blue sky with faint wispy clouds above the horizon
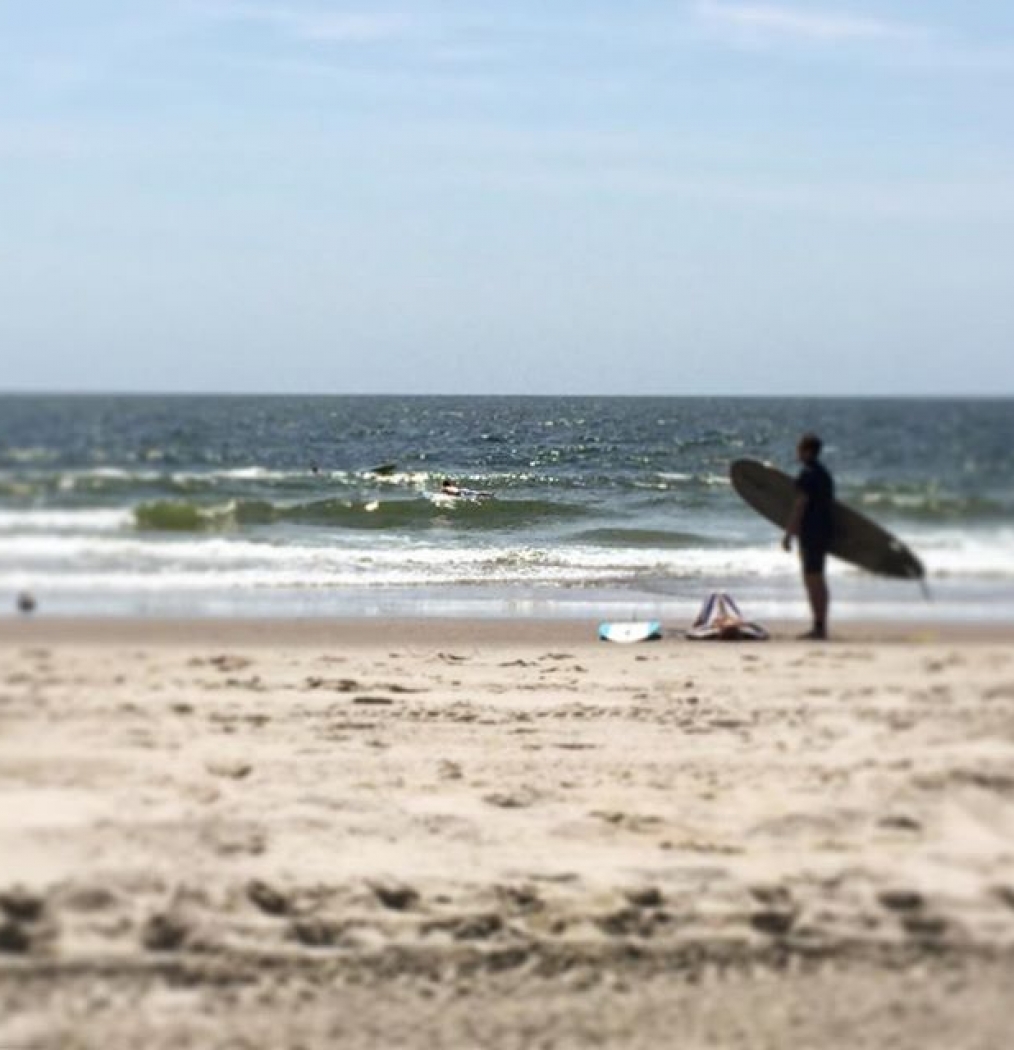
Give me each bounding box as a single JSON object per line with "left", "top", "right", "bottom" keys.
{"left": 0, "top": 0, "right": 1014, "bottom": 396}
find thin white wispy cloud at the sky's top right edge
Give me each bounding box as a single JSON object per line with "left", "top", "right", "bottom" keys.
{"left": 696, "top": 0, "right": 925, "bottom": 44}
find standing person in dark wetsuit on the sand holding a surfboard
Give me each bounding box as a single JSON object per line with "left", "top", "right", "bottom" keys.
{"left": 782, "top": 434, "right": 835, "bottom": 641}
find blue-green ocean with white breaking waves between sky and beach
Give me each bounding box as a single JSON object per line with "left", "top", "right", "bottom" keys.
{"left": 0, "top": 396, "right": 1014, "bottom": 624}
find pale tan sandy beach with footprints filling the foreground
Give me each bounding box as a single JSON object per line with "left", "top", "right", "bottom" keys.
{"left": 0, "top": 621, "right": 1014, "bottom": 1050}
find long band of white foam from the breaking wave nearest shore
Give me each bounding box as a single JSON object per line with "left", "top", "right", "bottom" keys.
{"left": 0, "top": 525, "right": 1014, "bottom": 583}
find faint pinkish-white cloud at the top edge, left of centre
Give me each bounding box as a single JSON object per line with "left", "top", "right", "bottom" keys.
{"left": 204, "top": 3, "right": 413, "bottom": 44}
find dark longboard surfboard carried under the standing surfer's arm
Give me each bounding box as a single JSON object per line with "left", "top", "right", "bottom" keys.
{"left": 728, "top": 459, "right": 925, "bottom": 580}
